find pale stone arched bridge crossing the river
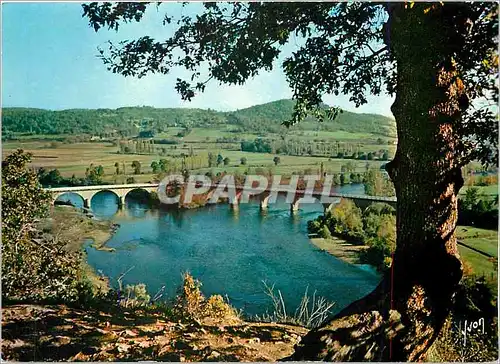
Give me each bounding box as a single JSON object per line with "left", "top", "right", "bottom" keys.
{"left": 46, "top": 183, "right": 397, "bottom": 213}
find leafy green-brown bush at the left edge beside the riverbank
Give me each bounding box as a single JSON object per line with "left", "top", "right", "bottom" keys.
{"left": 2, "top": 150, "right": 88, "bottom": 304}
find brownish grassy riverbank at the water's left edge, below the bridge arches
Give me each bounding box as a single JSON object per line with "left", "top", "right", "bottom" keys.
{"left": 39, "top": 205, "right": 118, "bottom": 292}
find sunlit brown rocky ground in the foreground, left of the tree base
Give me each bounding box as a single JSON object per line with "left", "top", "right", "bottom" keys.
{"left": 1, "top": 305, "right": 307, "bottom": 362}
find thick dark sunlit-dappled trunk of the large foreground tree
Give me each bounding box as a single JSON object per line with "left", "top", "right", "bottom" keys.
{"left": 288, "top": 3, "right": 468, "bottom": 361}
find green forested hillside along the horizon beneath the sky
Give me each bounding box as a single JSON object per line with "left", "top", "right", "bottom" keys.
{"left": 2, "top": 100, "right": 395, "bottom": 137}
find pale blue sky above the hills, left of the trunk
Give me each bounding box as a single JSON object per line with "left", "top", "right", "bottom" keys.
{"left": 1, "top": 3, "right": 393, "bottom": 116}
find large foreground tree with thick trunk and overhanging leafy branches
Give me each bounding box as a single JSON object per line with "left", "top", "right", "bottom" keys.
{"left": 83, "top": 3, "right": 498, "bottom": 361}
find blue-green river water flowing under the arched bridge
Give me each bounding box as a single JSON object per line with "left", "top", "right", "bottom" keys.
{"left": 59, "top": 185, "right": 380, "bottom": 315}
